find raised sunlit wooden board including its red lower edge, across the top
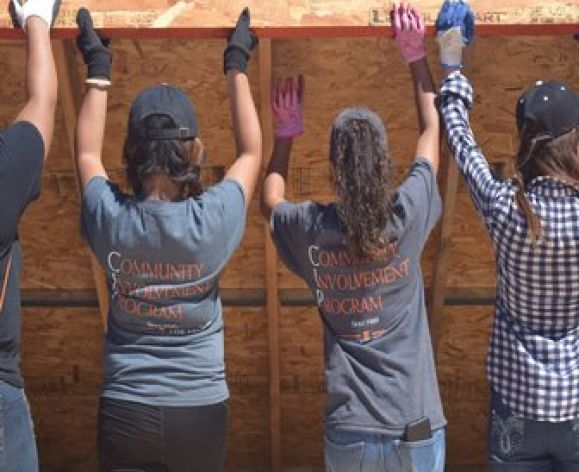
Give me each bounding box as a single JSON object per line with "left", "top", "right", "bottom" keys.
{"left": 0, "top": 0, "right": 579, "bottom": 39}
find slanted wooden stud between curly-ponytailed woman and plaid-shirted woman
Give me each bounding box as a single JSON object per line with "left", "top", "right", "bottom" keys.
{"left": 428, "top": 146, "right": 458, "bottom": 355}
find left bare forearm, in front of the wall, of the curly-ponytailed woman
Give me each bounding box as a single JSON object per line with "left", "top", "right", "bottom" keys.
{"left": 261, "top": 138, "right": 293, "bottom": 218}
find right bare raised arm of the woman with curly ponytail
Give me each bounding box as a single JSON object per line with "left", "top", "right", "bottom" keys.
{"left": 410, "top": 58, "right": 440, "bottom": 172}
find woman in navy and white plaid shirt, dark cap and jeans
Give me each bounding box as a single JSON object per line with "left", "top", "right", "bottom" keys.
{"left": 437, "top": 2, "right": 579, "bottom": 472}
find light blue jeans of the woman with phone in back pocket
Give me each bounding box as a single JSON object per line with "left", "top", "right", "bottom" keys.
{"left": 325, "top": 428, "right": 445, "bottom": 472}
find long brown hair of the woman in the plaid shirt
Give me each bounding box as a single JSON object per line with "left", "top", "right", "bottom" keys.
{"left": 514, "top": 120, "right": 579, "bottom": 244}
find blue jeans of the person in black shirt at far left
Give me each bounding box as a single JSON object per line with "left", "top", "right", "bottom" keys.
{"left": 0, "top": 380, "right": 38, "bottom": 472}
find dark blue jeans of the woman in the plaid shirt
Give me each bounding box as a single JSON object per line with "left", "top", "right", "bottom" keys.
{"left": 489, "top": 394, "right": 579, "bottom": 472}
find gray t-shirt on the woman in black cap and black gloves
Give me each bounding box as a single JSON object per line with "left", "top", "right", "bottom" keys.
{"left": 82, "top": 177, "right": 246, "bottom": 406}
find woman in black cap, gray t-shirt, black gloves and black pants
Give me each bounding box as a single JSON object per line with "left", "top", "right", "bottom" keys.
{"left": 76, "top": 10, "right": 261, "bottom": 472}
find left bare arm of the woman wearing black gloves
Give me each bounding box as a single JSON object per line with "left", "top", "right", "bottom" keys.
{"left": 75, "top": 86, "right": 108, "bottom": 189}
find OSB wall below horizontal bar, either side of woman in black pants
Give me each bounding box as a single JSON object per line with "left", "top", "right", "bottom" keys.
{"left": 22, "top": 309, "right": 269, "bottom": 472}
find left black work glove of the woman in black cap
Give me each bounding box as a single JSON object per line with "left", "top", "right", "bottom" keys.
{"left": 76, "top": 7, "right": 112, "bottom": 80}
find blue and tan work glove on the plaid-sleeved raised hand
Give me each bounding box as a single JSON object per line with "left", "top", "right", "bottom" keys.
{"left": 435, "top": 0, "right": 475, "bottom": 68}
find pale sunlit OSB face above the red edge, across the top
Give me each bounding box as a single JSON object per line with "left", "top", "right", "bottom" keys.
{"left": 0, "top": 0, "right": 579, "bottom": 29}
